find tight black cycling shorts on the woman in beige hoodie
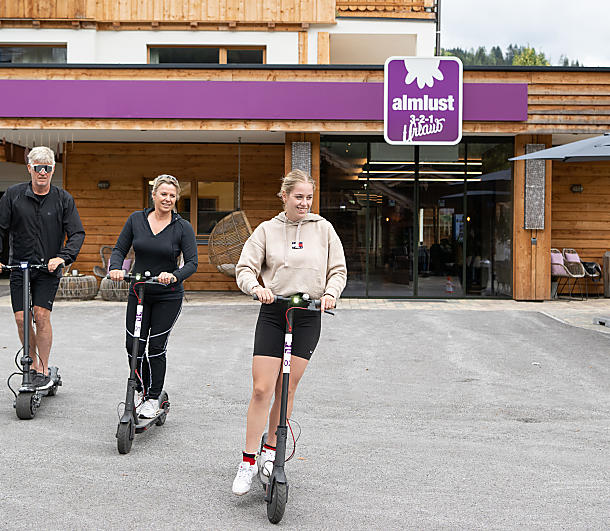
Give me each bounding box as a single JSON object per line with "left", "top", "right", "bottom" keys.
{"left": 254, "top": 302, "right": 322, "bottom": 360}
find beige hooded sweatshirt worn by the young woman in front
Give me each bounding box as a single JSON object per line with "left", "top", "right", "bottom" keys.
{"left": 235, "top": 212, "right": 347, "bottom": 299}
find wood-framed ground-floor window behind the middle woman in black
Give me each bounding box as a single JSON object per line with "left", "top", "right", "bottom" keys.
{"left": 146, "top": 179, "right": 237, "bottom": 240}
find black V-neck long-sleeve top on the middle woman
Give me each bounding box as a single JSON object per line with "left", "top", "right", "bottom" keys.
{"left": 110, "top": 208, "right": 198, "bottom": 299}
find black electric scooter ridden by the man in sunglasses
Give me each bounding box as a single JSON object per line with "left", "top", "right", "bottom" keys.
{"left": 2, "top": 262, "right": 62, "bottom": 420}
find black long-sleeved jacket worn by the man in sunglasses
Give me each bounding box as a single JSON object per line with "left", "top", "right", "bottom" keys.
{"left": 0, "top": 182, "right": 85, "bottom": 274}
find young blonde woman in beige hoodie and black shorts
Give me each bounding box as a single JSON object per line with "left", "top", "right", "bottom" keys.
{"left": 233, "top": 170, "right": 347, "bottom": 495}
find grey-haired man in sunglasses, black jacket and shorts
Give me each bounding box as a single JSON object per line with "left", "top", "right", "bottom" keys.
{"left": 0, "top": 146, "right": 85, "bottom": 388}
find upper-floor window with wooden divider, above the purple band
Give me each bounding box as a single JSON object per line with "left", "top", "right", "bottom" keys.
{"left": 148, "top": 46, "right": 265, "bottom": 65}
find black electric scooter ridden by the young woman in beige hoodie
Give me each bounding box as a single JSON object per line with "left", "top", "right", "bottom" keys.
{"left": 253, "top": 294, "right": 334, "bottom": 524}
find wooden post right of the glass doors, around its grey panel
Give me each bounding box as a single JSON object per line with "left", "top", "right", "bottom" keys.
{"left": 513, "top": 135, "right": 552, "bottom": 301}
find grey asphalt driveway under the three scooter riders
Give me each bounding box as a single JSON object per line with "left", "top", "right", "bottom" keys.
{"left": 0, "top": 301, "right": 610, "bottom": 529}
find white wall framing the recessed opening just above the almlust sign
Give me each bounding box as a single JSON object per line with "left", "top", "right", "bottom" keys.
{"left": 307, "top": 18, "right": 436, "bottom": 64}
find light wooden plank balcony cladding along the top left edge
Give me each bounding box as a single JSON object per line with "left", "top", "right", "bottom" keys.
{"left": 0, "top": 0, "right": 335, "bottom": 29}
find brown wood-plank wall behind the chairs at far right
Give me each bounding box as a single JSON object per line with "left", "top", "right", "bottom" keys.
{"left": 551, "top": 161, "right": 610, "bottom": 293}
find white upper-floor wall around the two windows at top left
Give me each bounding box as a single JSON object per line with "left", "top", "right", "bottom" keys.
{"left": 0, "top": 28, "right": 299, "bottom": 64}
